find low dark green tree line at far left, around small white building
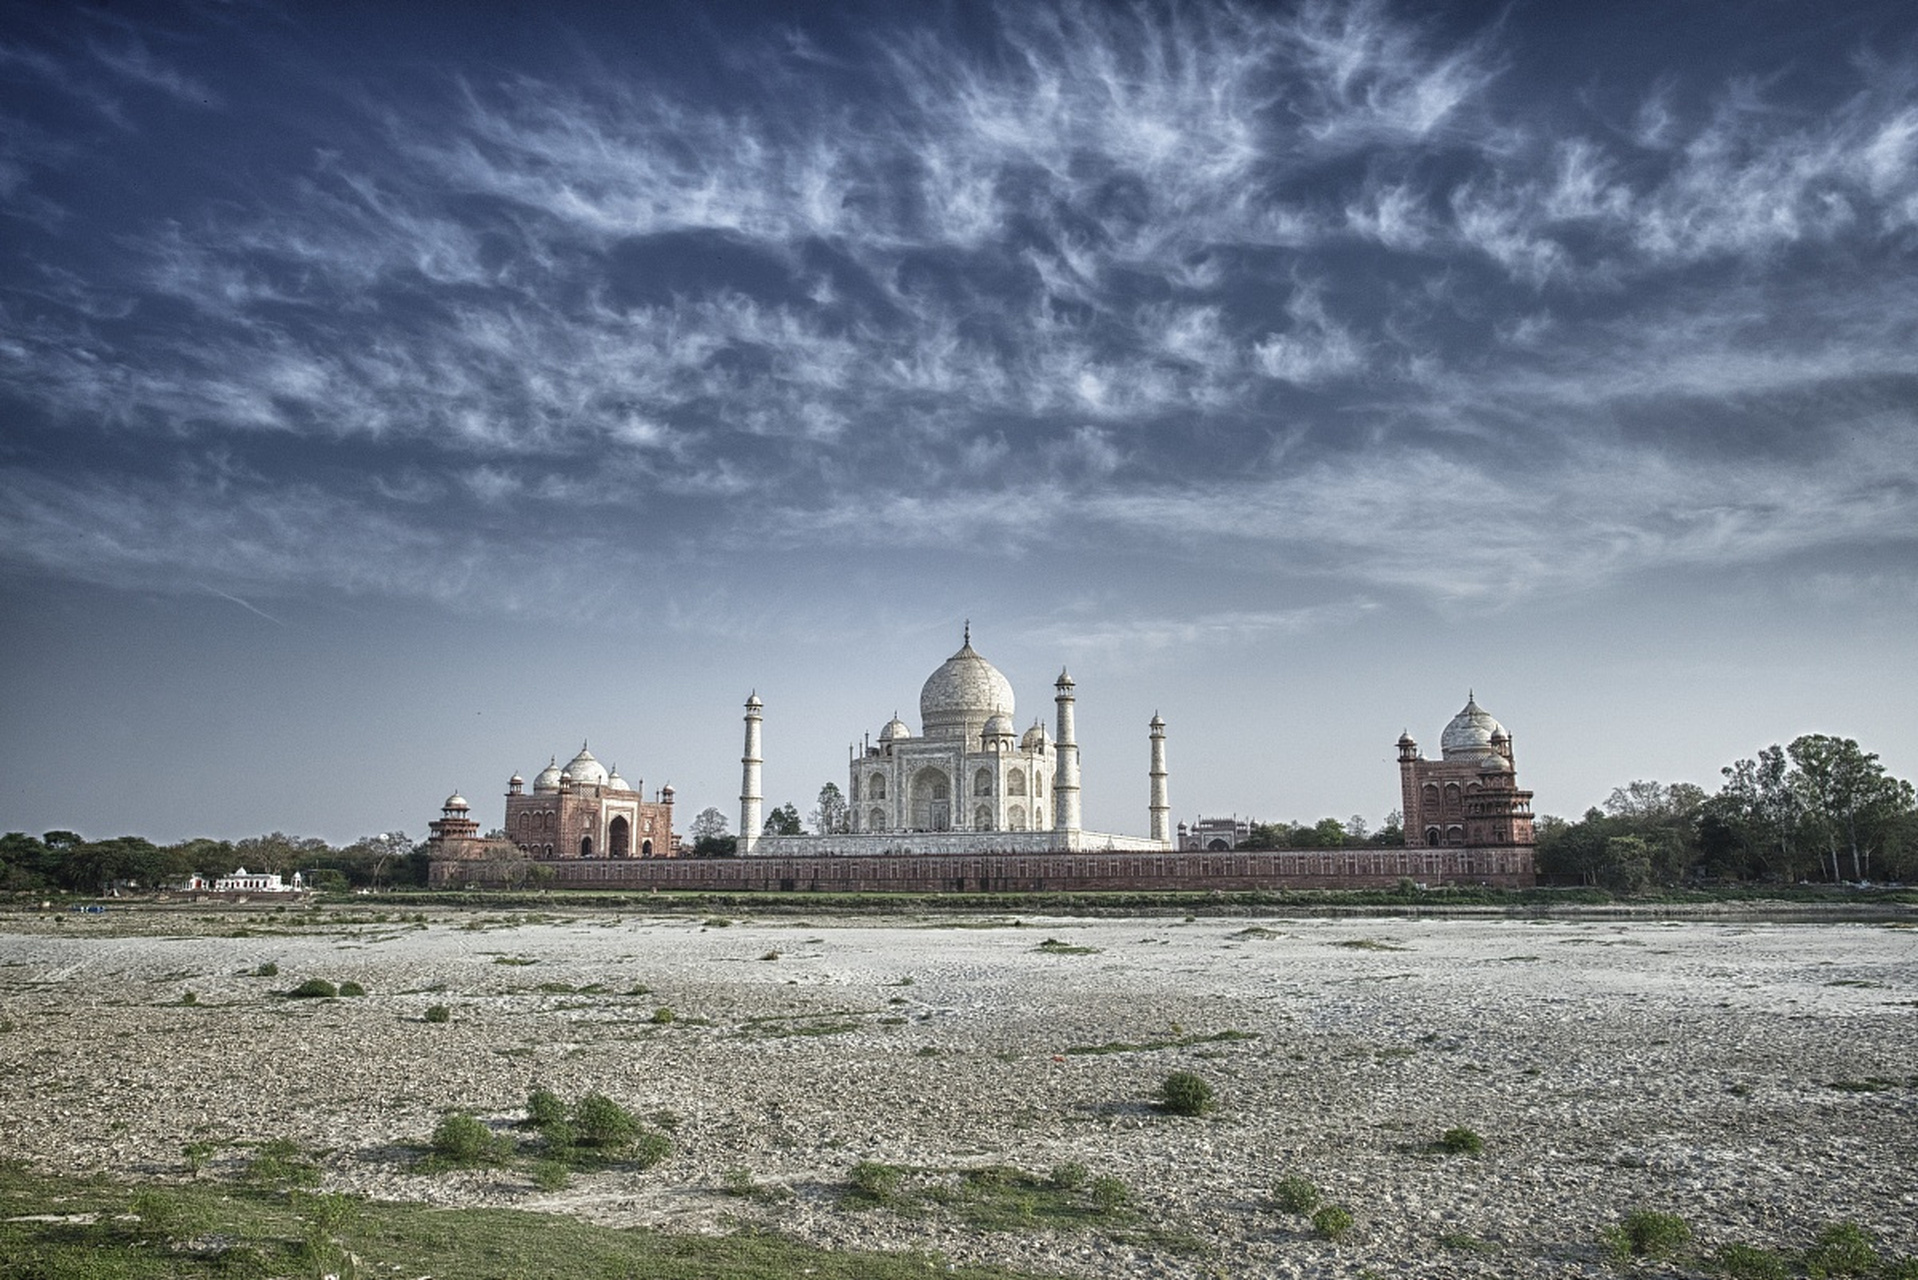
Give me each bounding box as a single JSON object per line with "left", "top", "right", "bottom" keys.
{"left": 0, "top": 831, "right": 428, "bottom": 894}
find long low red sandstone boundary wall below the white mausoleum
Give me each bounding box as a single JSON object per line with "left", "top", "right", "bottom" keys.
{"left": 430, "top": 844, "right": 1536, "bottom": 892}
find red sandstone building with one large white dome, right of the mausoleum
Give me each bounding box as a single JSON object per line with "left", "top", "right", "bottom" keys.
{"left": 1398, "top": 693, "right": 1534, "bottom": 848}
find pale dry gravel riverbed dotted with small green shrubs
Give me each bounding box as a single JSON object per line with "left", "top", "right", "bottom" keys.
{"left": 0, "top": 910, "right": 1918, "bottom": 1276}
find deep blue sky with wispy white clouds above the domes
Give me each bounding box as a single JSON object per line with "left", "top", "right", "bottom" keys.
{"left": 0, "top": 2, "right": 1918, "bottom": 841}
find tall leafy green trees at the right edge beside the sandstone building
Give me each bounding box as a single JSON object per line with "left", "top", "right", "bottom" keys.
{"left": 1536, "top": 733, "right": 1918, "bottom": 892}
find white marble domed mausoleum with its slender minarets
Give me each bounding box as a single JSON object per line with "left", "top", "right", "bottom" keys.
{"left": 738, "top": 626, "right": 1172, "bottom": 856}
